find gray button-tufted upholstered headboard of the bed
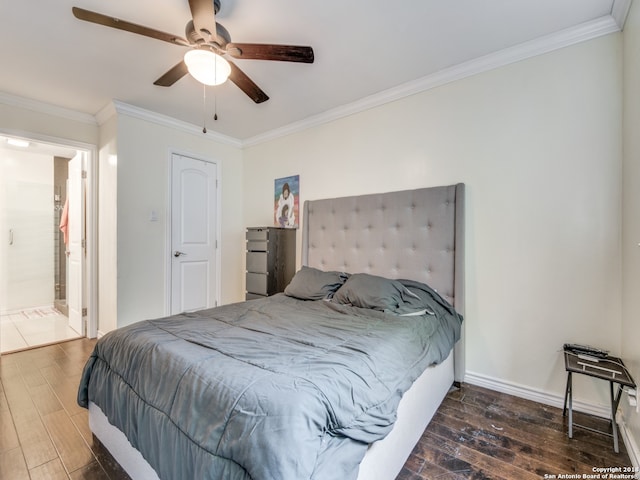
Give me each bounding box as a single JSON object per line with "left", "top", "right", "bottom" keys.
{"left": 302, "top": 183, "right": 465, "bottom": 381}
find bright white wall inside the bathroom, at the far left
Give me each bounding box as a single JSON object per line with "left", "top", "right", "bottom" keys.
{"left": 0, "top": 148, "right": 55, "bottom": 312}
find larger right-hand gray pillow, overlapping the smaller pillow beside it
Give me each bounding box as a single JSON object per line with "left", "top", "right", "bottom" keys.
{"left": 332, "top": 273, "right": 408, "bottom": 312}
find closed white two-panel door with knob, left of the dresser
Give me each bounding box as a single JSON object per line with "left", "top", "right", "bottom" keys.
{"left": 170, "top": 154, "right": 217, "bottom": 314}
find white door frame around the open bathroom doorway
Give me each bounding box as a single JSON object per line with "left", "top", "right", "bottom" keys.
{"left": 0, "top": 128, "right": 98, "bottom": 338}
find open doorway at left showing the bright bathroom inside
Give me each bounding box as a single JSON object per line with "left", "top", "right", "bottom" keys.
{"left": 0, "top": 132, "right": 96, "bottom": 353}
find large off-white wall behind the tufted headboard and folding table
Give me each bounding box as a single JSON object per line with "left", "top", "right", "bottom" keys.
{"left": 244, "top": 34, "right": 622, "bottom": 405}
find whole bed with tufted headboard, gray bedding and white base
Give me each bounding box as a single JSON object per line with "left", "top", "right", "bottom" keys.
{"left": 78, "top": 184, "right": 464, "bottom": 480}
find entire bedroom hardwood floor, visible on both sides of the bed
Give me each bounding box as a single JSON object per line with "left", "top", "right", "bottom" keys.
{"left": 0, "top": 339, "right": 631, "bottom": 480}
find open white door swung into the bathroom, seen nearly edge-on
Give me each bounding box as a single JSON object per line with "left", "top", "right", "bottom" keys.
{"left": 67, "top": 153, "right": 85, "bottom": 336}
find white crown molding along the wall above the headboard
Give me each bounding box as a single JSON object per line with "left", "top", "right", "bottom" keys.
{"left": 242, "top": 15, "right": 631, "bottom": 147}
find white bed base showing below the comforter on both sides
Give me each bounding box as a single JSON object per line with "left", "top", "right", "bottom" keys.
{"left": 89, "top": 354, "right": 453, "bottom": 480}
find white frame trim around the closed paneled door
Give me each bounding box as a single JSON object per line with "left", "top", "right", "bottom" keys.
{"left": 164, "top": 148, "right": 222, "bottom": 315}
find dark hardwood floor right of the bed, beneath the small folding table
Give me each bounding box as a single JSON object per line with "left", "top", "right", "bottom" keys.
{"left": 397, "top": 384, "right": 631, "bottom": 480}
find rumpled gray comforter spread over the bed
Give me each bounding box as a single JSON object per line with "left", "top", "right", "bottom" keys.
{"left": 78, "top": 294, "right": 461, "bottom": 480}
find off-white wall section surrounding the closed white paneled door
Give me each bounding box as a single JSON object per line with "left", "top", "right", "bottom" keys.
{"left": 107, "top": 113, "right": 244, "bottom": 327}
